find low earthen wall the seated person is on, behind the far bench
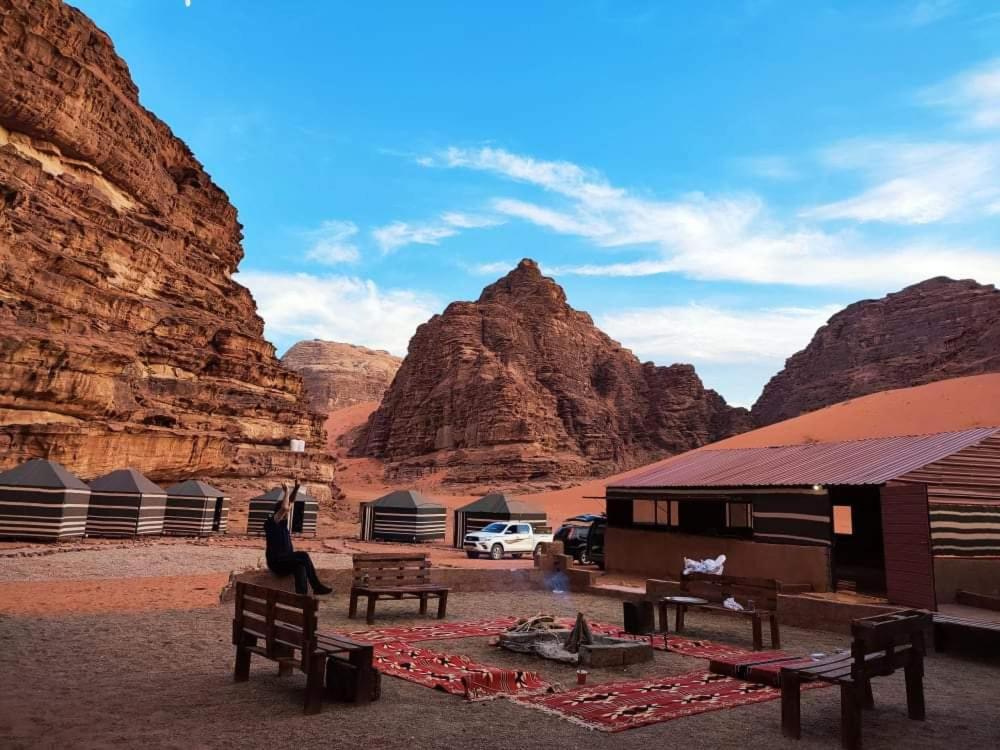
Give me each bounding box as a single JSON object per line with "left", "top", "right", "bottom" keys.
{"left": 220, "top": 568, "right": 551, "bottom": 602}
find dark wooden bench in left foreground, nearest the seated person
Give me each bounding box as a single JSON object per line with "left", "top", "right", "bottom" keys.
{"left": 233, "top": 581, "right": 379, "bottom": 714}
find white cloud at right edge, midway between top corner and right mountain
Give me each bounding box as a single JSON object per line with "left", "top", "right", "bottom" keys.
{"left": 801, "top": 140, "right": 1000, "bottom": 224}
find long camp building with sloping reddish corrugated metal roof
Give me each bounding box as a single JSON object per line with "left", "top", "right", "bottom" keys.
{"left": 606, "top": 427, "right": 1000, "bottom": 609}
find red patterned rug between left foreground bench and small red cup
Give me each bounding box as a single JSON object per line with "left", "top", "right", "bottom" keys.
{"left": 375, "top": 641, "right": 549, "bottom": 700}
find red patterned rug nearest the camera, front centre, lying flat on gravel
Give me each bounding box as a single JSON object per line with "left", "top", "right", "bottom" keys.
{"left": 512, "top": 671, "right": 781, "bottom": 732}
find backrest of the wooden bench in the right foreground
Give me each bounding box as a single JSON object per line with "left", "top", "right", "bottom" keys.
{"left": 851, "top": 609, "right": 932, "bottom": 676}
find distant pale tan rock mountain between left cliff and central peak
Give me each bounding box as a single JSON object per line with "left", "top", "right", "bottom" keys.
{"left": 281, "top": 339, "right": 403, "bottom": 414}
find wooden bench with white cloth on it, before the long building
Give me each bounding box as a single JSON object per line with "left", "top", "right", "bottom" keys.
{"left": 657, "top": 573, "right": 796, "bottom": 651}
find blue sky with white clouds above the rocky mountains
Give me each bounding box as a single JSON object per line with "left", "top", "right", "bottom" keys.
{"left": 76, "top": 0, "right": 1000, "bottom": 405}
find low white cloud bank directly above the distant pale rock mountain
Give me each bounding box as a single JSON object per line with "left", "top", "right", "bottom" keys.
{"left": 234, "top": 271, "right": 440, "bottom": 356}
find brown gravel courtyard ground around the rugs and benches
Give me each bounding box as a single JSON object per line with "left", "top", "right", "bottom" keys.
{"left": 0, "top": 592, "right": 1000, "bottom": 750}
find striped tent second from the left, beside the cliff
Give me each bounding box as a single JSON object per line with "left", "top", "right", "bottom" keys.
{"left": 87, "top": 469, "right": 167, "bottom": 537}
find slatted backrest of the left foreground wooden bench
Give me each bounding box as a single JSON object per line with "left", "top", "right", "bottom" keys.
{"left": 233, "top": 581, "right": 317, "bottom": 671}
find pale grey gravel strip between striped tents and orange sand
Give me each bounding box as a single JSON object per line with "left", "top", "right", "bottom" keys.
{"left": 0, "top": 544, "right": 351, "bottom": 581}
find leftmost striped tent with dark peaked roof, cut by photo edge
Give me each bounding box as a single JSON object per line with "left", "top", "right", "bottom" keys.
{"left": 0, "top": 458, "right": 90, "bottom": 542}
